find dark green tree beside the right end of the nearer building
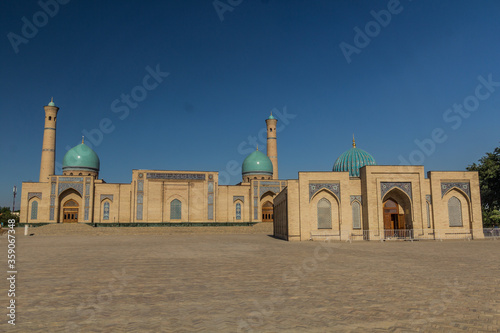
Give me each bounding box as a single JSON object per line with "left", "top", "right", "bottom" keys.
{"left": 467, "top": 147, "right": 500, "bottom": 227}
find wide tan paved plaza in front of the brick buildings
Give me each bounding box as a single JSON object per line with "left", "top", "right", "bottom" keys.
{"left": 0, "top": 224, "right": 500, "bottom": 332}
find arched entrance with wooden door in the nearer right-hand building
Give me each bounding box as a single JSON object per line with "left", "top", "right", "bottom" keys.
{"left": 383, "top": 190, "right": 413, "bottom": 238}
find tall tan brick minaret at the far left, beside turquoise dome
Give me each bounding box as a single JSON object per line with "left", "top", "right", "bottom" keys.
{"left": 39, "top": 99, "right": 59, "bottom": 183}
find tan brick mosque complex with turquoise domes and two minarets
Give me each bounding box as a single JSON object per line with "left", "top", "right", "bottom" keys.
{"left": 20, "top": 101, "right": 483, "bottom": 241}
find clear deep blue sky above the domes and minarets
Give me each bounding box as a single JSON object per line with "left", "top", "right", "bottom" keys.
{"left": 0, "top": 0, "right": 500, "bottom": 208}
